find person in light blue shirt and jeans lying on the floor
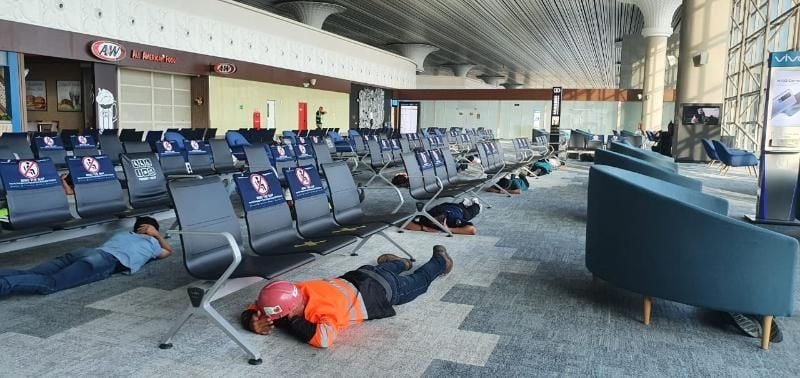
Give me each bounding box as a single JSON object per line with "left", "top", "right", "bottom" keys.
{"left": 0, "top": 217, "right": 172, "bottom": 297}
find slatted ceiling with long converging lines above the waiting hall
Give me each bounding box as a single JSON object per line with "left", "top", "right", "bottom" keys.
{"left": 238, "top": 0, "right": 644, "bottom": 88}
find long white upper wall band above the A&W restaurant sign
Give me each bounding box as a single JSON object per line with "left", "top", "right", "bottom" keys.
{"left": 0, "top": 0, "right": 416, "bottom": 89}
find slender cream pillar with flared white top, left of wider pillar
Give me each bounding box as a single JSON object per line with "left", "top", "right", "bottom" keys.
{"left": 625, "top": 0, "right": 681, "bottom": 130}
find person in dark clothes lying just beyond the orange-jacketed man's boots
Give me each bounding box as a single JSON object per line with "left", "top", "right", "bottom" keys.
{"left": 405, "top": 198, "right": 481, "bottom": 235}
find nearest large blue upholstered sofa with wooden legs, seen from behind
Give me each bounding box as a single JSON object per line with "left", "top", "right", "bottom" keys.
{"left": 586, "top": 165, "right": 798, "bottom": 349}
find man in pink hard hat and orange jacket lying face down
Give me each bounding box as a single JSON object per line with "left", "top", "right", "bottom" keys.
{"left": 241, "top": 245, "right": 453, "bottom": 348}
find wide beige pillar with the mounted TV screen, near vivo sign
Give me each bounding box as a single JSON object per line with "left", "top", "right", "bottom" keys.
{"left": 672, "top": 0, "right": 735, "bottom": 161}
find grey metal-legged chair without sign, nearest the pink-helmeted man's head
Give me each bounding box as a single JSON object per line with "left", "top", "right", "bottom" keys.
{"left": 159, "top": 176, "right": 314, "bottom": 365}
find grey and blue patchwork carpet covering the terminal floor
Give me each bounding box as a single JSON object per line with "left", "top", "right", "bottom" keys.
{"left": 0, "top": 157, "right": 800, "bottom": 377}
